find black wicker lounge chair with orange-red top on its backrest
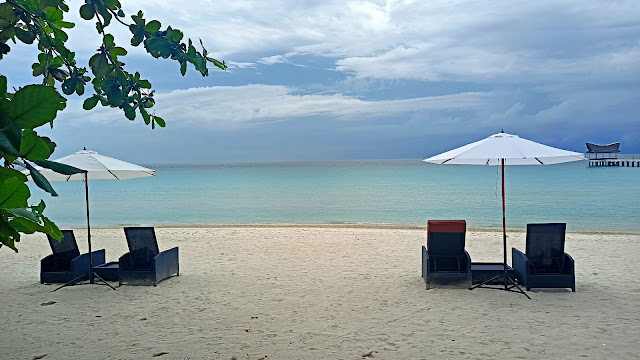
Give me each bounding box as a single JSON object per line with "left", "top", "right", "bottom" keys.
{"left": 422, "top": 220, "right": 471, "bottom": 289}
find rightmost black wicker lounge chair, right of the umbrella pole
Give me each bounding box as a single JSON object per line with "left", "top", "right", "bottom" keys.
{"left": 512, "top": 223, "right": 576, "bottom": 292}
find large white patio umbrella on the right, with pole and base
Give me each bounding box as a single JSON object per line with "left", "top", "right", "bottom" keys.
{"left": 423, "top": 131, "right": 585, "bottom": 297}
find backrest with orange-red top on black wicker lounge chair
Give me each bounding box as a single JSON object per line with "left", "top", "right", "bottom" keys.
{"left": 427, "top": 220, "right": 467, "bottom": 256}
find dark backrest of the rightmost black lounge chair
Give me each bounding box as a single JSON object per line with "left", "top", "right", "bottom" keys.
{"left": 526, "top": 223, "right": 567, "bottom": 267}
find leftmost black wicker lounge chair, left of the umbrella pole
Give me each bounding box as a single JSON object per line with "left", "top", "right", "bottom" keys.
{"left": 40, "top": 230, "right": 105, "bottom": 284}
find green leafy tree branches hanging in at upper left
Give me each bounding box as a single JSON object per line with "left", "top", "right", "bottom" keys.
{"left": 0, "top": 0, "right": 227, "bottom": 251}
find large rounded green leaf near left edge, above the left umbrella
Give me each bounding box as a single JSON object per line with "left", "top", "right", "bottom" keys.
{"left": 9, "top": 85, "right": 62, "bottom": 129}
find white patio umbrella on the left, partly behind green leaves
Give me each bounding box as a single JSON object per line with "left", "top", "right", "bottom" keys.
{"left": 28, "top": 148, "right": 155, "bottom": 290}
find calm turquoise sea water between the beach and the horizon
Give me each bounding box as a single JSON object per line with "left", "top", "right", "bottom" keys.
{"left": 32, "top": 159, "right": 640, "bottom": 231}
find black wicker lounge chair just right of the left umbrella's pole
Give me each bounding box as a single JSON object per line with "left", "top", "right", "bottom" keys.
{"left": 118, "top": 227, "right": 180, "bottom": 286}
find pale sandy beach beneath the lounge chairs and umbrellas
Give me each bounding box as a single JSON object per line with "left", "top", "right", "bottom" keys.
{"left": 0, "top": 227, "right": 640, "bottom": 360}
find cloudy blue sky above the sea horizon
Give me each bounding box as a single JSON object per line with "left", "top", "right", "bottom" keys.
{"left": 0, "top": 0, "right": 640, "bottom": 164}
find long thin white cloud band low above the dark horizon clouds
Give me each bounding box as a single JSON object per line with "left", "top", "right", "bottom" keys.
{"left": 60, "top": 85, "right": 490, "bottom": 128}
